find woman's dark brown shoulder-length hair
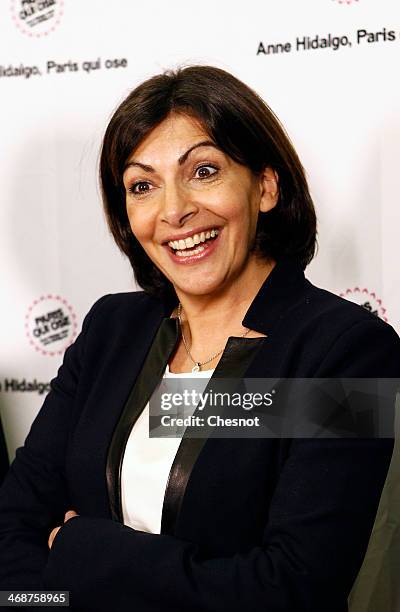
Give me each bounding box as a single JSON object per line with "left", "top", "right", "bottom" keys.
{"left": 100, "top": 66, "right": 316, "bottom": 297}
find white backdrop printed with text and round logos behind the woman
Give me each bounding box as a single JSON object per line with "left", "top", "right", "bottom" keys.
{"left": 0, "top": 0, "right": 400, "bottom": 612}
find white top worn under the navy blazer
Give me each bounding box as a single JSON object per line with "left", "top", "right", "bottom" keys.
{"left": 121, "top": 365, "right": 214, "bottom": 533}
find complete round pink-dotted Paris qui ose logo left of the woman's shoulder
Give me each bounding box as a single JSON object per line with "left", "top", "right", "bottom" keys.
{"left": 25, "top": 295, "right": 77, "bottom": 357}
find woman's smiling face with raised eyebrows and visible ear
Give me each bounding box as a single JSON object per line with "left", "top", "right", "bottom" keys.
{"left": 123, "top": 114, "right": 278, "bottom": 297}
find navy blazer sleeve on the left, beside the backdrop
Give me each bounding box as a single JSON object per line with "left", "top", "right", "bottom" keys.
{"left": 0, "top": 296, "right": 107, "bottom": 590}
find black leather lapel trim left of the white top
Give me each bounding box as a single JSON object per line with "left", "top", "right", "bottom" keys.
{"left": 106, "top": 318, "right": 179, "bottom": 523}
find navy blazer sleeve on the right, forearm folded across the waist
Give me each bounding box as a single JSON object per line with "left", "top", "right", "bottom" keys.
{"left": 44, "top": 318, "right": 400, "bottom": 612}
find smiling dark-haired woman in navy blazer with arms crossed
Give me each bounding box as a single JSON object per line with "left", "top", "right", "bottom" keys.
{"left": 0, "top": 66, "right": 400, "bottom": 612}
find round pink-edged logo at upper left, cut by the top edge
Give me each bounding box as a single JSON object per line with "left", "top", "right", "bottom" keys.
{"left": 11, "top": 0, "right": 64, "bottom": 38}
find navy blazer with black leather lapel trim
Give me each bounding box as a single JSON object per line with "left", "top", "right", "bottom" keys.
{"left": 0, "top": 262, "right": 400, "bottom": 612}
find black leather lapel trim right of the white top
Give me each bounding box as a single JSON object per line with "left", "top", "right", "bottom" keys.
{"left": 161, "top": 337, "right": 266, "bottom": 535}
